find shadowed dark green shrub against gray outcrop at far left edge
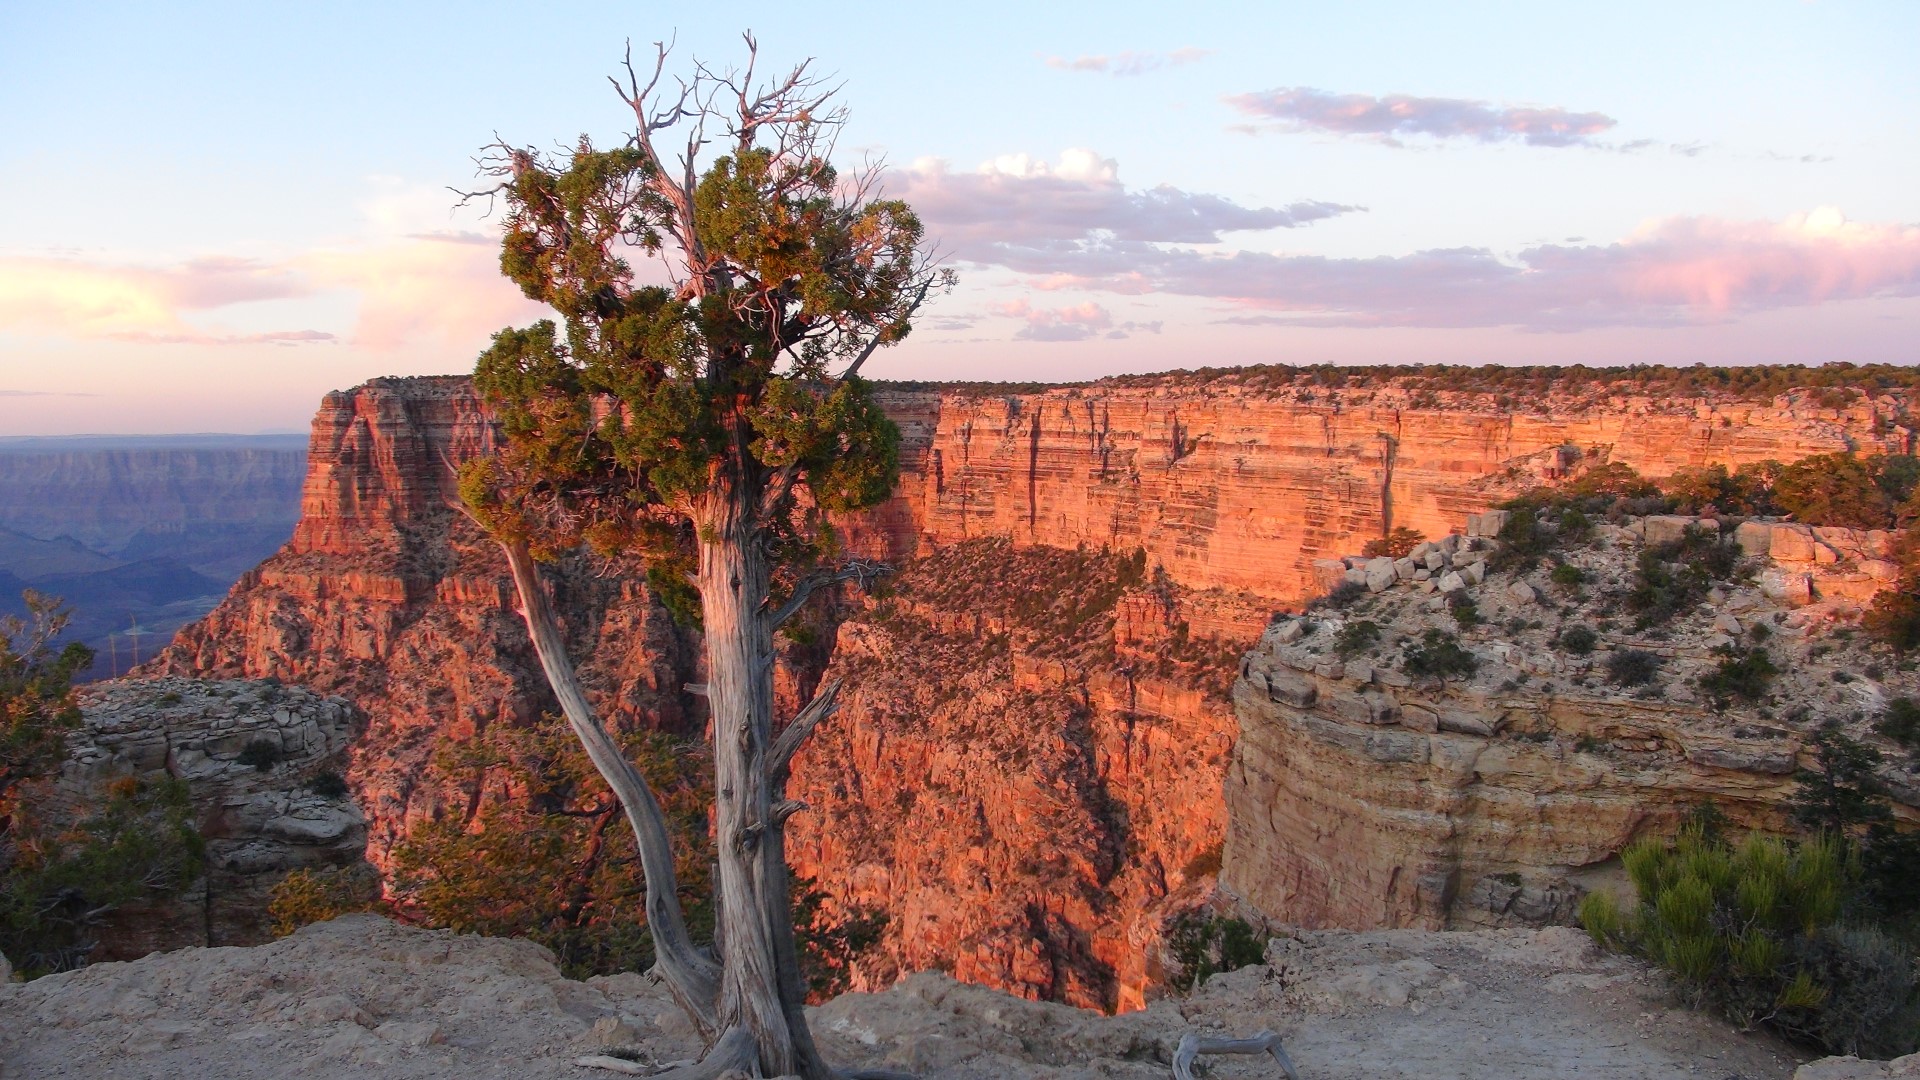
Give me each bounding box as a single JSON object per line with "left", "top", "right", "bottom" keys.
{"left": 0, "top": 776, "right": 205, "bottom": 976}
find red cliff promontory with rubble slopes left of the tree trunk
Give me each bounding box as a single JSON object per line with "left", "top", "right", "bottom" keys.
{"left": 148, "top": 379, "right": 695, "bottom": 867}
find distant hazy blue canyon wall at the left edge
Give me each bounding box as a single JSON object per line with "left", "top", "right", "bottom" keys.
{"left": 0, "top": 434, "right": 307, "bottom": 676}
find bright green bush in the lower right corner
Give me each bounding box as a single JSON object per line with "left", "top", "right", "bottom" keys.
{"left": 1580, "top": 826, "right": 1920, "bottom": 1055}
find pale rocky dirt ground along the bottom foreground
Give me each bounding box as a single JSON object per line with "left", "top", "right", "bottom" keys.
{"left": 0, "top": 915, "right": 1896, "bottom": 1080}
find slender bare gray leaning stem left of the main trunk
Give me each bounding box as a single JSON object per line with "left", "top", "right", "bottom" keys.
{"left": 501, "top": 540, "right": 720, "bottom": 1034}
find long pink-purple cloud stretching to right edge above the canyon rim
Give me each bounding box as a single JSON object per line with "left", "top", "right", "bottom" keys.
{"left": 1002, "top": 209, "right": 1920, "bottom": 331}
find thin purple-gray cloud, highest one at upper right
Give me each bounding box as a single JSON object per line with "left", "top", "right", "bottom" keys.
{"left": 1227, "top": 86, "right": 1617, "bottom": 146}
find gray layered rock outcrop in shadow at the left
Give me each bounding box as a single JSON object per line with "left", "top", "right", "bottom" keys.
{"left": 31, "top": 678, "right": 367, "bottom": 963}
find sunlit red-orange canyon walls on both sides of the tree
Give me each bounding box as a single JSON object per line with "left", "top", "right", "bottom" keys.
{"left": 146, "top": 369, "right": 1908, "bottom": 1009}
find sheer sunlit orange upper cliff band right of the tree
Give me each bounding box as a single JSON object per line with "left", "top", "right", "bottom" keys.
{"left": 889, "top": 377, "right": 1905, "bottom": 607}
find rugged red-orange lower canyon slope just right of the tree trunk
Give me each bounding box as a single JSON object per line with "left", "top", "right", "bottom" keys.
{"left": 789, "top": 540, "right": 1233, "bottom": 1011}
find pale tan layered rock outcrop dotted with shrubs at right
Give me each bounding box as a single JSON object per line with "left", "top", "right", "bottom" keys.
{"left": 1221, "top": 519, "right": 1920, "bottom": 928}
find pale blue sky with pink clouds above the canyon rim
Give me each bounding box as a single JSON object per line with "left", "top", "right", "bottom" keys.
{"left": 0, "top": 0, "right": 1920, "bottom": 434}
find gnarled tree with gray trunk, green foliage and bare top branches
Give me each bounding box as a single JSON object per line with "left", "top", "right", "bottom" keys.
{"left": 461, "top": 35, "right": 950, "bottom": 1080}
